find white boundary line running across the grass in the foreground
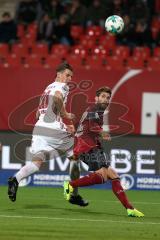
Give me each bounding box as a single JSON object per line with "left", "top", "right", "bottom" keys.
{"left": 0, "top": 215, "right": 160, "bottom": 225}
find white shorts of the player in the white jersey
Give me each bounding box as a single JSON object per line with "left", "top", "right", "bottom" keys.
{"left": 30, "top": 121, "right": 74, "bottom": 160}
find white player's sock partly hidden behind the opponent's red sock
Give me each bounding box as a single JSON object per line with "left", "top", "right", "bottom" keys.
{"left": 69, "top": 160, "right": 80, "bottom": 196}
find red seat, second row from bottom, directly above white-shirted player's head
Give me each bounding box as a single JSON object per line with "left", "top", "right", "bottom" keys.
{"left": 51, "top": 44, "right": 69, "bottom": 58}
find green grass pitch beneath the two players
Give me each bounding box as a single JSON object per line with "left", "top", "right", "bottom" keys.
{"left": 0, "top": 186, "right": 160, "bottom": 240}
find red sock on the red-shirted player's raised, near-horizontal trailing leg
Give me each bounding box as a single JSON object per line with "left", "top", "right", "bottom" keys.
{"left": 69, "top": 173, "right": 104, "bottom": 188}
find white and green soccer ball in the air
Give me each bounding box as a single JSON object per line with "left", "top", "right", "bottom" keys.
{"left": 105, "top": 15, "right": 124, "bottom": 34}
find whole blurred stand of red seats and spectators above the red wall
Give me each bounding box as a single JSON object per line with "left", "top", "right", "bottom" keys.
{"left": 0, "top": 0, "right": 160, "bottom": 70}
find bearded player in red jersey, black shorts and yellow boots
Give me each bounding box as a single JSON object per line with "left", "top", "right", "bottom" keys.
{"left": 64, "top": 87, "right": 144, "bottom": 217}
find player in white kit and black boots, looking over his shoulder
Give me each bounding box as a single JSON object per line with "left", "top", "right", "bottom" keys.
{"left": 8, "top": 62, "right": 88, "bottom": 206}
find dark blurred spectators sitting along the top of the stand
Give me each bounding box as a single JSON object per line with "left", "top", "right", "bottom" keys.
{"left": 0, "top": 0, "right": 160, "bottom": 47}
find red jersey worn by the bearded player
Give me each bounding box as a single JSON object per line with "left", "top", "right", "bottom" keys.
{"left": 74, "top": 104, "right": 104, "bottom": 156}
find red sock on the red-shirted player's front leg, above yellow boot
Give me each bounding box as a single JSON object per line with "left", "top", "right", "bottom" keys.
{"left": 112, "top": 179, "right": 134, "bottom": 209}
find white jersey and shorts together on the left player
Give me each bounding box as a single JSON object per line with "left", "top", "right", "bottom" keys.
{"left": 30, "top": 82, "right": 74, "bottom": 159}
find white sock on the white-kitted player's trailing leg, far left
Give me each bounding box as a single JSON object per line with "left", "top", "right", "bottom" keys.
{"left": 15, "top": 162, "right": 39, "bottom": 183}
